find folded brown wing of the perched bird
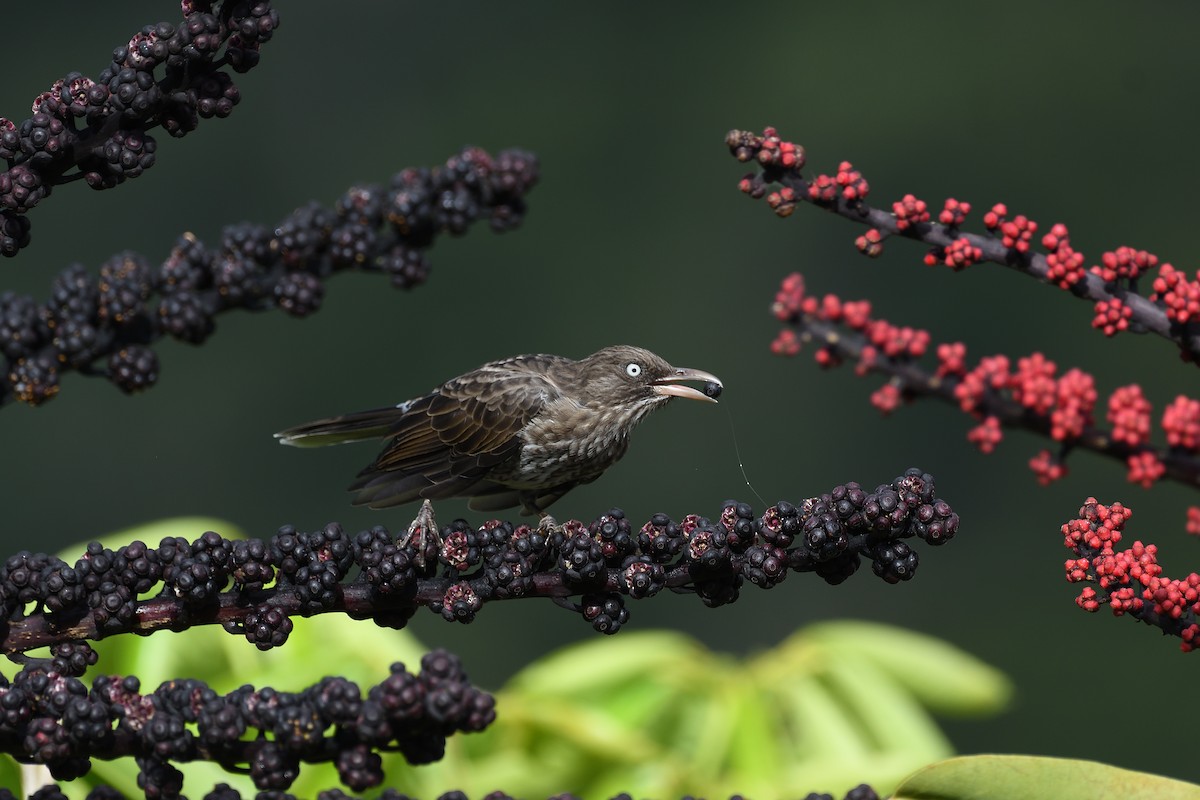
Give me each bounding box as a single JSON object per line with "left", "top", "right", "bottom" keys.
{"left": 350, "top": 356, "right": 559, "bottom": 507}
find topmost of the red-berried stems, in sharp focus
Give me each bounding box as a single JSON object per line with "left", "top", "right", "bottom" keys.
{"left": 726, "top": 127, "right": 1200, "bottom": 362}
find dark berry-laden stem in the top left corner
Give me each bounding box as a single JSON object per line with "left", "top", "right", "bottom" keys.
{"left": 0, "top": 0, "right": 280, "bottom": 255}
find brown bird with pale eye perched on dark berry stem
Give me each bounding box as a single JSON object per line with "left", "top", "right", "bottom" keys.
{"left": 275, "top": 345, "right": 722, "bottom": 513}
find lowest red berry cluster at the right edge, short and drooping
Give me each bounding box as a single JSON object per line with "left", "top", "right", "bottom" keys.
{"left": 1062, "top": 498, "right": 1200, "bottom": 652}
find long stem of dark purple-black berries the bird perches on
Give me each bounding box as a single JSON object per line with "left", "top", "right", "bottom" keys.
{"left": 0, "top": 469, "right": 959, "bottom": 657}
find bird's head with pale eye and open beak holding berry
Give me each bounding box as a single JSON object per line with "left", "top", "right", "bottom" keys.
{"left": 578, "top": 344, "right": 724, "bottom": 410}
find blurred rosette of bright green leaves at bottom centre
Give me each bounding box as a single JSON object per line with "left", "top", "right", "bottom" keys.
{"left": 477, "top": 622, "right": 1007, "bottom": 796}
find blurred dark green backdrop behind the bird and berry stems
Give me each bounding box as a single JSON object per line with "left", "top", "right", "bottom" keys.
{"left": 0, "top": 0, "right": 1200, "bottom": 780}
